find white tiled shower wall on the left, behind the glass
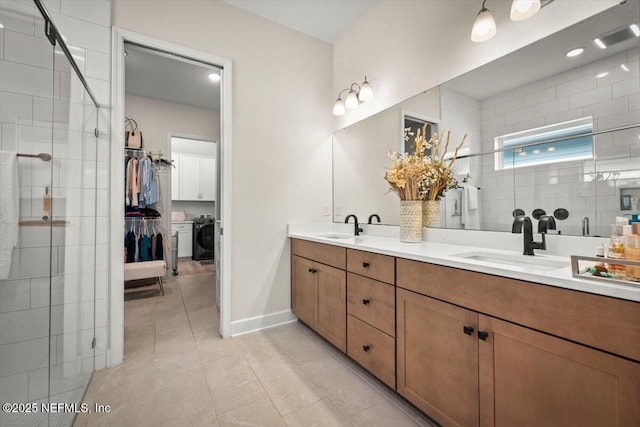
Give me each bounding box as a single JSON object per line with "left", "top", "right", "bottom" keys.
{"left": 0, "top": 0, "right": 111, "bottom": 425}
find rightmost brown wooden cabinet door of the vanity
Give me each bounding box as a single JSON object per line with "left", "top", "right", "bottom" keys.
{"left": 479, "top": 315, "right": 640, "bottom": 427}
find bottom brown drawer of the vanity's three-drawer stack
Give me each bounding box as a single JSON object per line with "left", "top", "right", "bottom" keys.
{"left": 347, "top": 314, "right": 396, "bottom": 390}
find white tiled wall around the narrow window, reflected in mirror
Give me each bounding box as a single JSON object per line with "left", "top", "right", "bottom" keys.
{"left": 479, "top": 49, "right": 640, "bottom": 235}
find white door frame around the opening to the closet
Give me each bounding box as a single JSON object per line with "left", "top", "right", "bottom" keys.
{"left": 105, "top": 26, "right": 233, "bottom": 367}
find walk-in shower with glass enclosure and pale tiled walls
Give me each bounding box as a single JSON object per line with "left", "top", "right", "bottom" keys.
{"left": 0, "top": 0, "right": 109, "bottom": 426}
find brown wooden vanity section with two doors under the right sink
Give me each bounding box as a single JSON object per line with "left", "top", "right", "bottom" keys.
{"left": 396, "top": 259, "right": 640, "bottom": 426}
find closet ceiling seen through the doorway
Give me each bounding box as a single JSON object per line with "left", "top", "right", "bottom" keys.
{"left": 125, "top": 43, "right": 220, "bottom": 111}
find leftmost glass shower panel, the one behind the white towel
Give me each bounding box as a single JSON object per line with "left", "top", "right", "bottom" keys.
{"left": 0, "top": 0, "right": 55, "bottom": 426}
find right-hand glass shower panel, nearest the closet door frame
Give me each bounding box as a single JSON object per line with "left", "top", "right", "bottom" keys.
{"left": 49, "top": 36, "right": 97, "bottom": 425}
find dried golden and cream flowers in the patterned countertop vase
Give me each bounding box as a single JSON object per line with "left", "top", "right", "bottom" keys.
{"left": 384, "top": 125, "right": 467, "bottom": 200}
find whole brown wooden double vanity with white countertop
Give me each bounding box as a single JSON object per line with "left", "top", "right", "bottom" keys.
{"left": 289, "top": 225, "right": 640, "bottom": 426}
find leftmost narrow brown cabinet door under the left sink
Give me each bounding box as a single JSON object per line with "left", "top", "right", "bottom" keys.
{"left": 291, "top": 255, "right": 318, "bottom": 328}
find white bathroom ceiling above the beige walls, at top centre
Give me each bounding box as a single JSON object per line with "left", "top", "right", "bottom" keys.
{"left": 225, "top": 0, "right": 378, "bottom": 44}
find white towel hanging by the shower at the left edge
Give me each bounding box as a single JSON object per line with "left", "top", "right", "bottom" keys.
{"left": 0, "top": 151, "right": 20, "bottom": 279}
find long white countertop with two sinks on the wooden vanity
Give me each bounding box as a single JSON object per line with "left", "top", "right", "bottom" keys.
{"left": 289, "top": 223, "right": 640, "bottom": 302}
